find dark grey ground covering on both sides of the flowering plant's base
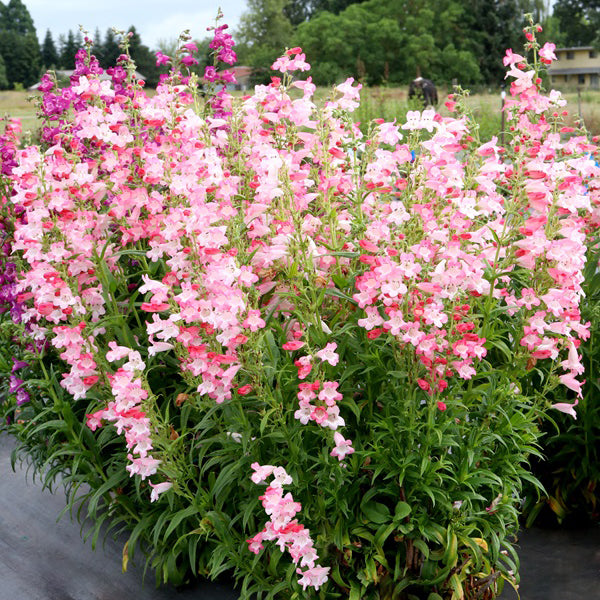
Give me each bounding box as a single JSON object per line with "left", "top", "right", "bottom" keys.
{"left": 0, "top": 436, "right": 600, "bottom": 600}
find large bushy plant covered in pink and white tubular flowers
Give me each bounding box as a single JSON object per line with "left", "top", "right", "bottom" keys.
{"left": 0, "top": 12, "right": 598, "bottom": 600}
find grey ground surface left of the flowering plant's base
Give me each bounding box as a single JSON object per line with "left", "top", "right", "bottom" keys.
{"left": 0, "top": 435, "right": 238, "bottom": 600}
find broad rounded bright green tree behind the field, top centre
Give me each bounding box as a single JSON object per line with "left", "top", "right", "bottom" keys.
{"left": 293, "top": 0, "right": 481, "bottom": 85}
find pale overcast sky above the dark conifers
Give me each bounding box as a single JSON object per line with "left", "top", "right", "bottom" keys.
{"left": 23, "top": 0, "right": 246, "bottom": 49}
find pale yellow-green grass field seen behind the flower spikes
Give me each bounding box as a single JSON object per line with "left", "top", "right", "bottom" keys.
{"left": 0, "top": 87, "right": 600, "bottom": 140}
